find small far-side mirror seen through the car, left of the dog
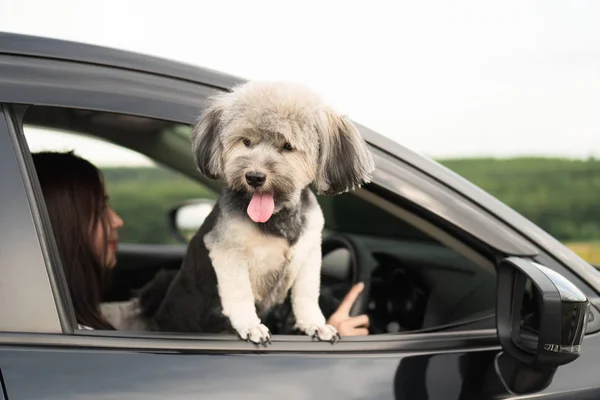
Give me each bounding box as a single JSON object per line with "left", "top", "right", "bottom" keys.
{"left": 167, "top": 199, "right": 215, "bottom": 244}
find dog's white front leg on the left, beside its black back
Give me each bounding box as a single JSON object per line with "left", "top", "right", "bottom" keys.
{"left": 213, "top": 251, "right": 271, "bottom": 344}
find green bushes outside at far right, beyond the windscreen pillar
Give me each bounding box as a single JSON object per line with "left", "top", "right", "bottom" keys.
{"left": 440, "top": 158, "right": 600, "bottom": 242}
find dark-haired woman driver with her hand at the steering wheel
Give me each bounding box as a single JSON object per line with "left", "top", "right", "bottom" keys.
{"left": 32, "top": 152, "right": 369, "bottom": 336}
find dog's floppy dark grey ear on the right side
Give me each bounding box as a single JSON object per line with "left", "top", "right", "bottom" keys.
{"left": 315, "top": 110, "right": 375, "bottom": 195}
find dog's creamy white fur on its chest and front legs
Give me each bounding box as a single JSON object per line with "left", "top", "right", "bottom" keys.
{"left": 204, "top": 195, "right": 337, "bottom": 342}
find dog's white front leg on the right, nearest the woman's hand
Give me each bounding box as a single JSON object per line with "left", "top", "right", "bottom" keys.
{"left": 292, "top": 244, "right": 340, "bottom": 342}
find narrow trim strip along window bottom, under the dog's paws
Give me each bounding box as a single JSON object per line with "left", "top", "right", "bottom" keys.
{"left": 0, "top": 329, "right": 501, "bottom": 354}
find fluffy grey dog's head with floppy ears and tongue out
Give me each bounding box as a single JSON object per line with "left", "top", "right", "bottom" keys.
{"left": 191, "top": 82, "right": 375, "bottom": 222}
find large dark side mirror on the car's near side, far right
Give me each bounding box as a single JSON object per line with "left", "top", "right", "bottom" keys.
{"left": 494, "top": 257, "right": 590, "bottom": 395}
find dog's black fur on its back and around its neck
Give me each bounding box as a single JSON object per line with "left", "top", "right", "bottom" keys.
{"left": 140, "top": 188, "right": 316, "bottom": 334}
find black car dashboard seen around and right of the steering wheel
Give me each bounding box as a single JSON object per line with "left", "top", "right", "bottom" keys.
{"left": 321, "top": 235, "right": 496, "bottom": 334}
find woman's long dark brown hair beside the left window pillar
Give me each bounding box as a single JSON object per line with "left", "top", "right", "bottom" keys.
{"left": 32, "top": 152, "right": 114, "bottom": 330}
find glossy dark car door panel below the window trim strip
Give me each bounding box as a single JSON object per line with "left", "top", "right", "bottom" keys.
{"left": 0, "top": 349, "right": 494, "bottom": 400}
